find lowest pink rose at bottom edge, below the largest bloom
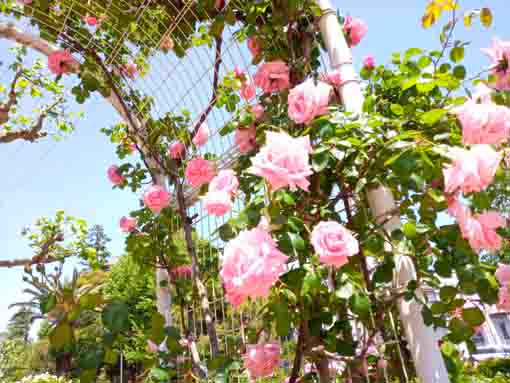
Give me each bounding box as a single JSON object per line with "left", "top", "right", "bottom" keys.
{"left": 243, "top": 342, "right": 281, "bottom": 381}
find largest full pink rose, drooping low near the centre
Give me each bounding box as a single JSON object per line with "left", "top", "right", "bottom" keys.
{"left": 220, "top": 227, "right": 288, "bottom": 306}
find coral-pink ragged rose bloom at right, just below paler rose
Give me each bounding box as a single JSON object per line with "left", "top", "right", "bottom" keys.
{"left": 448, "top": 197, "right": 506, "bottom": 252}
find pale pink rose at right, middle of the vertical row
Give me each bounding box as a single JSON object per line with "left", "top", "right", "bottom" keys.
{"left": 443, "top": 145, "right": 502, "bottom": 193}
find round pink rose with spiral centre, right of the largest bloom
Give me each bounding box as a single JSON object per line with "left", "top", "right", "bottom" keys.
{"left": 311, "top": 221, "right": 359, "bottom": 267}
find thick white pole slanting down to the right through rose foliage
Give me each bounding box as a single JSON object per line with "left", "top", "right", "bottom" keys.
{"left": 316, "top": 0, "right": 449, "bottom": 383}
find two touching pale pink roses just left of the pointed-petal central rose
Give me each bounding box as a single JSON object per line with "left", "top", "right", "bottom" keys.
{"left": 202, "top": 169, "right": 239, "bottom": 217}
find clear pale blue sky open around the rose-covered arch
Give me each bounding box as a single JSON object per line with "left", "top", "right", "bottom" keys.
{"left": 0, "top": 0, "right": 510, "bottom": 331}
